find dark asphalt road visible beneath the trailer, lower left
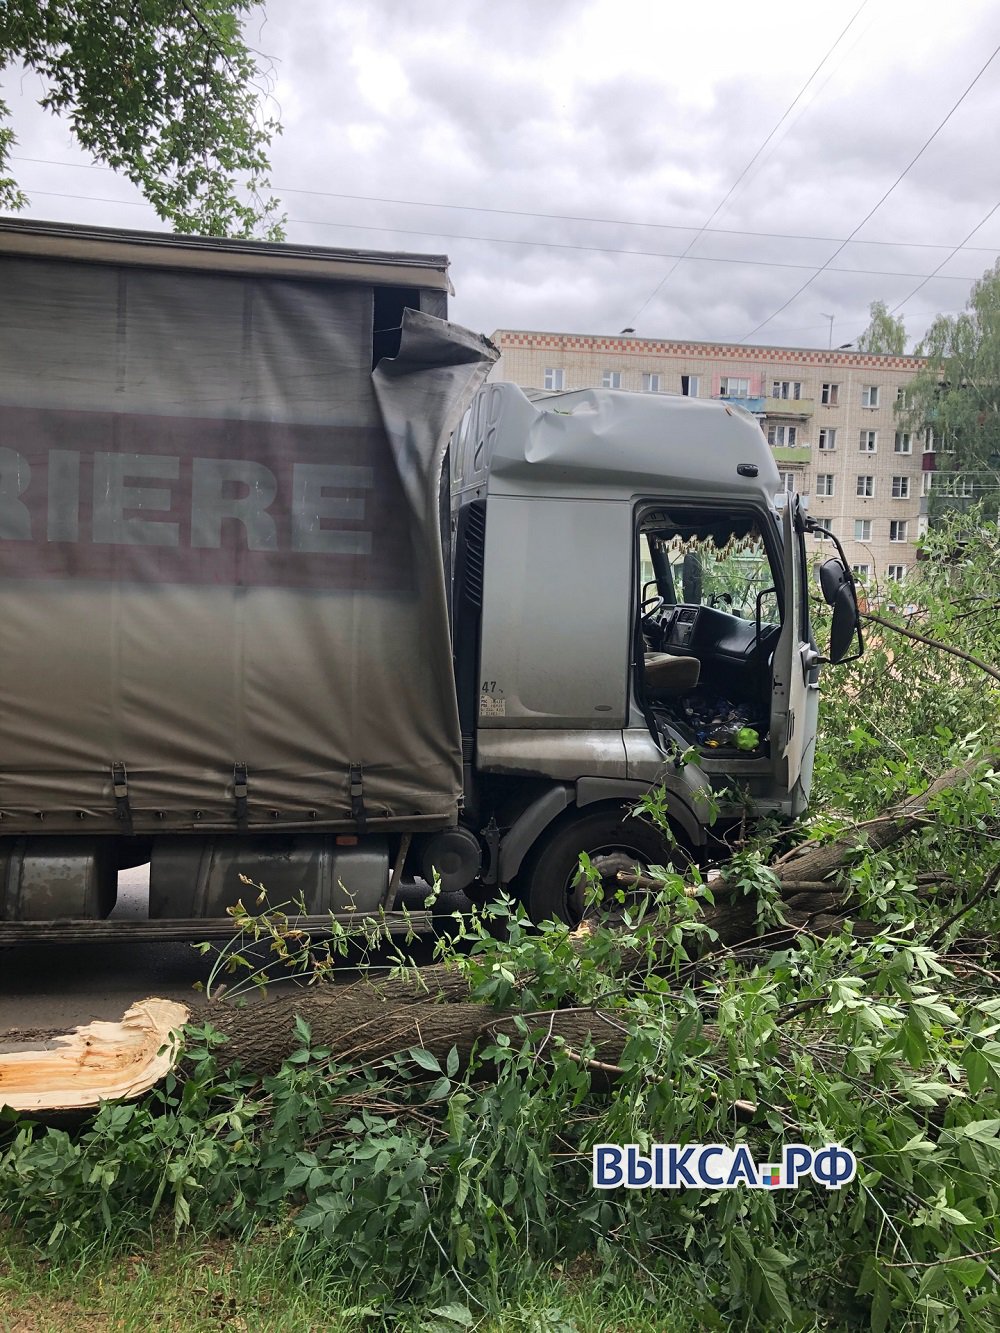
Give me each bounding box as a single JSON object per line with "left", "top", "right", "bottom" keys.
{"left": 0, "top": 866, "right": 464, "bottom": 1046}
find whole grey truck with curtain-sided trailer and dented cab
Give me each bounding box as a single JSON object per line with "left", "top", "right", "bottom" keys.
{"left": 0, "top": 219, "right": 860, "bottom": 942}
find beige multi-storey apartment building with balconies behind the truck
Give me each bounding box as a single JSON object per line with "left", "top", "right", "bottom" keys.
{"left": 491, "top": 329, "right": 936, "bottom": 584}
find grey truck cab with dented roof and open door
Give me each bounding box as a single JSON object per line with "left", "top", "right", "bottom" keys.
{"left": 452, "top": 384, "right": 857, "bottom": 920}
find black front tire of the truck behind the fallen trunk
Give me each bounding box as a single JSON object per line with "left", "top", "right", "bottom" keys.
{"left": 516, "top": 806, "right": 688, "bottom": 926}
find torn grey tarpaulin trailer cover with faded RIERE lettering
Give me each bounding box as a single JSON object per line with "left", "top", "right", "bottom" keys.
{"left": 0, "top": 223, "right": 493, "bottom": 834}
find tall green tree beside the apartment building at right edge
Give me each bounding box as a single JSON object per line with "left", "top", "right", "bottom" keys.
{"left": 905, "top": 261, "right": 1000, "bottom": 485}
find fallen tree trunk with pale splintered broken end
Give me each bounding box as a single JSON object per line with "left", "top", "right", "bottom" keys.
{"left": 0, "top": 758, "right": 997, "bottom": 1113}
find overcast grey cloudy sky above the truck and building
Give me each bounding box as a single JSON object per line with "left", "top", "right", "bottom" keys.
{"left": 3, "top": 0, "right": 1000, "bottom": 347}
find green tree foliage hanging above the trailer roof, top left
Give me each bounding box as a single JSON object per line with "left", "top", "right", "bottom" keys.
{"left": 0, "top": 0, "right": 281, "bottom": 239}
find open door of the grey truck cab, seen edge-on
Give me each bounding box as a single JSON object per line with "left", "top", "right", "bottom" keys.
{"left": 771, "top": 495, "right": 819, "bottom": 814}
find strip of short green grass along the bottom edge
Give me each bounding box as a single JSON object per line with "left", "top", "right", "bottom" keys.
{"left": 0, "top": 1232, "right": 746, "bottom": 1333}
